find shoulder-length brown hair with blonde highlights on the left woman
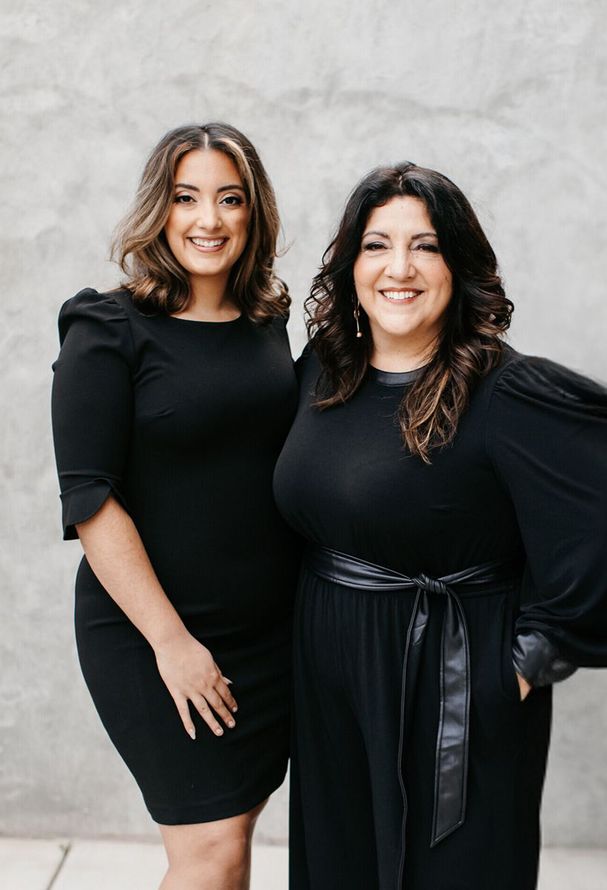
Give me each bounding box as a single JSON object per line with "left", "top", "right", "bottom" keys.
{"left": 112, "top": 123, "right": 291, "bottom": 321}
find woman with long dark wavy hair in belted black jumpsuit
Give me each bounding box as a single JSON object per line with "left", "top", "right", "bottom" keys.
{"left": 274, "top": 163, "right": 607, "bottom": 890}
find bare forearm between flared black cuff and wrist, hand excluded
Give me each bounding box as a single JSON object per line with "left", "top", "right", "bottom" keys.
{"left": 77, "top": 498, "right": 187, "bottom": 650}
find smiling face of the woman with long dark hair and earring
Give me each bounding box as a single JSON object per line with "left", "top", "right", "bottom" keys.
{"left": 353, "top": 196, "right": 453, "bottom": 370}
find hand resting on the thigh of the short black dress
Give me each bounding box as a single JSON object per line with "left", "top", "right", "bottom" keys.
{"left": 154, "top": 632, "right": 238, "bottom": 739}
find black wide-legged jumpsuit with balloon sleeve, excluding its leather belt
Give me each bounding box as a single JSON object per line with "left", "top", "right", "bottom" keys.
{"left": 274, "top": 349, "right": 607, "bottom": 890}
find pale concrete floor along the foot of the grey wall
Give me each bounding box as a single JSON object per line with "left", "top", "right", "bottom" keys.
{"left": 0, "top": 838, "right": 607, "bottom": 890}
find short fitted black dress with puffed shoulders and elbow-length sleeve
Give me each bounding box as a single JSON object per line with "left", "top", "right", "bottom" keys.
{"left": 53, "top": 289, "right": 297, "bottom": 824}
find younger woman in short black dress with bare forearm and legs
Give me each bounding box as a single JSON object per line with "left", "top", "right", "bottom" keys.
{"left": 53, "top": 123, "right": 297, "bottom": 890}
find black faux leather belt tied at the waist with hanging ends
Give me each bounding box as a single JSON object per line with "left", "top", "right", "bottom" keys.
{"left": 305, "top": 547, "right": 519, "bottom": 846}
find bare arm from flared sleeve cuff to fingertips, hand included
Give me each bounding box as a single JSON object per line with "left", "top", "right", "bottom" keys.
{"left": 77, "top": 497, "right": 237, "bottom": 738}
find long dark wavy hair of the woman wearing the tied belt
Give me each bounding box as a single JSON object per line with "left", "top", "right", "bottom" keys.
{"left": 306, "top": 162, "right": 514, "bottom": 463}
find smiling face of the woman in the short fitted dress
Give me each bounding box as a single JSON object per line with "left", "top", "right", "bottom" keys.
{"left": 164, "top": 149, "right": 250, "bottom": 290}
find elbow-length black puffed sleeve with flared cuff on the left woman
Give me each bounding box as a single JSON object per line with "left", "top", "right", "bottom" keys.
{"left": 52, "top": 289, "right": 133, "bottom": 540}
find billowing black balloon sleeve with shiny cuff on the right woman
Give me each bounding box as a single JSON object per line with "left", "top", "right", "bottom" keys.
{"left": 488, "top": 356, "right": 607, "bottom": 686}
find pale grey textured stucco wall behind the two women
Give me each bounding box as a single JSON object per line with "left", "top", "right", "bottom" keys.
{"left": 0, "top": 0, "right": 607, "bottom": 845}
